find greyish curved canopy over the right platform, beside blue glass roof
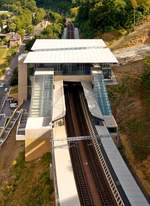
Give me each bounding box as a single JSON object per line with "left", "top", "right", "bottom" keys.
{"left": 81, "top": 81, "right": 103, "bottom": 119}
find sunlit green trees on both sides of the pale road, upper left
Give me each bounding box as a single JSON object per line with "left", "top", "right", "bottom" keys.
{"left": 0, "top": 0, "right": 64, "bottom": 38}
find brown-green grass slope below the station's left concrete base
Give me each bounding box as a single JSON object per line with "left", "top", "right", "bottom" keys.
{"left": 0, "top": 152, "right": 54, "bottom": 206}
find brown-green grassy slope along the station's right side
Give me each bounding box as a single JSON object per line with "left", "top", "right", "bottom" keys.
{"left": 109, "top": 61, "right": 150, "bottom": 198}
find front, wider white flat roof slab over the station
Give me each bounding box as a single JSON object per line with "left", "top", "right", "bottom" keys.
{"left": 24, "top": 48, "right": 118, "bottom": 64}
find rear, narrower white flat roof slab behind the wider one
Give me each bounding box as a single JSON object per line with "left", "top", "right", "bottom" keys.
{"left": 32, "top": 39, "right": 106, "bottom": 51}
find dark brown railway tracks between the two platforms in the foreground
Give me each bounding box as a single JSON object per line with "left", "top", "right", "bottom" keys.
{"left": 65, "top": 85, "right": 116, "bottom": 206}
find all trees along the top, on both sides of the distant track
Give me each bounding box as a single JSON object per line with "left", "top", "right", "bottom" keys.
{"left": 0, "top": 0, "right": 150, "bottom": 38}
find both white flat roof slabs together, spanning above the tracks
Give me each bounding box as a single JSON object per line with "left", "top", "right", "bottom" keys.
{"left": 24, "top": 39, "right": 118, "bottom": 64}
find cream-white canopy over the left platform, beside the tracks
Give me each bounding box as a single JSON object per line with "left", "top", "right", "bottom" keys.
{"left": 52, "top": 81, "right": 66, "bottom": 121}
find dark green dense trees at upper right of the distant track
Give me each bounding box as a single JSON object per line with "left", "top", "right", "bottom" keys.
{"left": 73, "top": 0, "right": 150, "bottom": 37}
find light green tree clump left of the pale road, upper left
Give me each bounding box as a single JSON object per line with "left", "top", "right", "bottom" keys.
{"left": 0, "top": 0, "right": 46, "bottom": 36}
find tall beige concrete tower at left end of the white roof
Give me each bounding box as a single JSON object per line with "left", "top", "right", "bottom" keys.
{"left": 18, "top": 54, "right": 28, "bottom": 105}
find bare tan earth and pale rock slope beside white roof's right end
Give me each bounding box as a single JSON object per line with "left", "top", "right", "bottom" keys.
{"left": 110, "top": 16, "right": 150, "bottom": 64}
